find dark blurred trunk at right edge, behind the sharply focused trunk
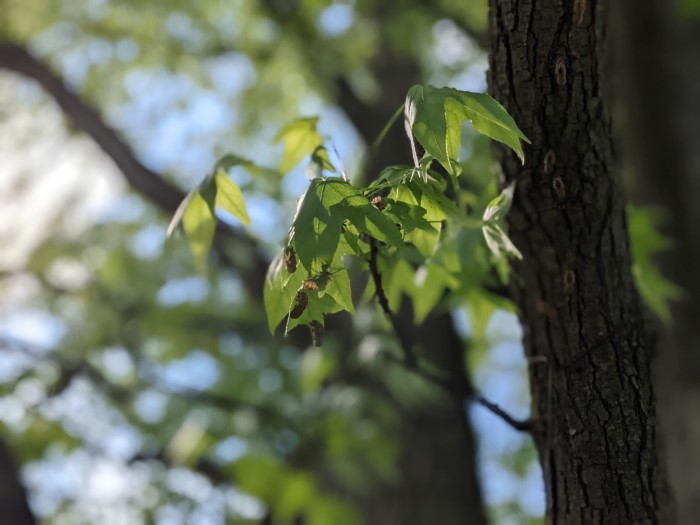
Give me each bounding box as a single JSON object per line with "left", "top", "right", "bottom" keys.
{"left": 614, "top": 0, "right": 700, "bottom": 525}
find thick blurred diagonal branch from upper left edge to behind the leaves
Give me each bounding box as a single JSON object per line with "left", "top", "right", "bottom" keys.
{"left": 0, "top": 43, "right": 268, "bottom": 296}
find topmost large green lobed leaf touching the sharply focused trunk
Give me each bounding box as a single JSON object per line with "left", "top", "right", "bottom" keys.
{"left": 405, "top": 85, "right": 527, "bottom": 171}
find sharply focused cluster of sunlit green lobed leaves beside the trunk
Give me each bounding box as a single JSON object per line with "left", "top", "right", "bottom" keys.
{"left": 171, "top": 86, "right": 527, "bottom": 344}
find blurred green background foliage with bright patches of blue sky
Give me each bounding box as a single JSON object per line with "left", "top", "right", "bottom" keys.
{"left": 0, "top": 0, "right": 678, "bottom": 525}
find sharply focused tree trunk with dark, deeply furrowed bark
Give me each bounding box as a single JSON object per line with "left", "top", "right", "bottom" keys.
{"left": 489, "top": 0, "right": 669, "bottom": 524}
